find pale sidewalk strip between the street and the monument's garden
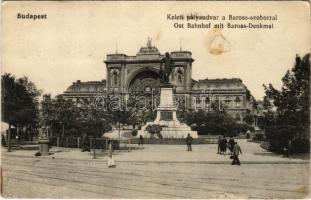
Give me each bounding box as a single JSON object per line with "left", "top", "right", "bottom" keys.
{"left": 2, "top": 139, "right": 309, "bottom": 164}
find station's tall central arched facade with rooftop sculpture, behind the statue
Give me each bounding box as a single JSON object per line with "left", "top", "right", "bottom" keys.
{"left": 104, "top": 40, "right": 194, "bottom": 94}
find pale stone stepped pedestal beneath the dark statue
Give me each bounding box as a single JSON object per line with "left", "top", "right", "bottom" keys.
{"left": 137, "top": 84, "right": 198, "bottom": 138}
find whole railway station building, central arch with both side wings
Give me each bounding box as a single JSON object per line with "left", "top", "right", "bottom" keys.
{"left": 63, "top": 40, "right": 256, "bottom": 121}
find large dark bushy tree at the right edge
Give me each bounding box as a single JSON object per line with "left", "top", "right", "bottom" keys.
{"left": 262, "top": 54, "right": 310, "bottom": 152}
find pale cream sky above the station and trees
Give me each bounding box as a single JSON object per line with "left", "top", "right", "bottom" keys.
{"left": 1, "top": 1, "right": 311, "bottom": 99}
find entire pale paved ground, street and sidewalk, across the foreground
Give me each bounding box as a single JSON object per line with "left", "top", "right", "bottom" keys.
{"left": 1, "top": 141, "right": 310, "bottom": 198}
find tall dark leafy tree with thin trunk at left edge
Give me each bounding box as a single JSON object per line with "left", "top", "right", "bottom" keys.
{"left": 1, "top": 73, "right": 41, "bottom": 150}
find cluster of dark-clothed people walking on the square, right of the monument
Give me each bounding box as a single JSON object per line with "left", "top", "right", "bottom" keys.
{"left": 217, "top": 136, "right": 242, "bottom": 165}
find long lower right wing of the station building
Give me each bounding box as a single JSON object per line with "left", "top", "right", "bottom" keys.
{"left": 191, "top": 78, "right": 256, "bottom": 121}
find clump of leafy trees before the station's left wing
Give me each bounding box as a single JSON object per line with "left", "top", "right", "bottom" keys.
{"left": 41, "top": 95, "right": 111, "bottom": 137}
